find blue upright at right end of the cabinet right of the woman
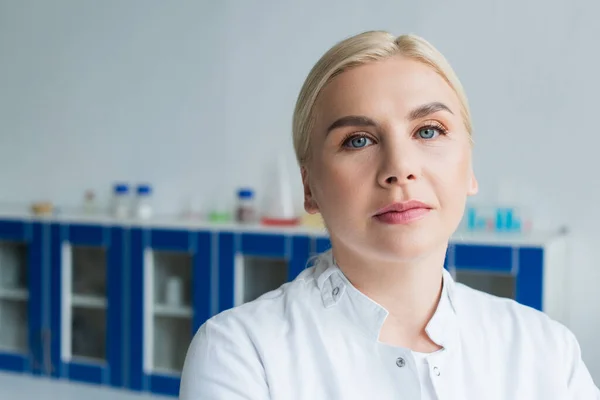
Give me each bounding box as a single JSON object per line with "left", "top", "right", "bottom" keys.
{"left": 516, "top": 248, "right": 544, "bottom": 310}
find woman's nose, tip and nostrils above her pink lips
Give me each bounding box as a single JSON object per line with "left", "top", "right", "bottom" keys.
{"left": 377, "top": 143, "right": 419, "bottom": 188}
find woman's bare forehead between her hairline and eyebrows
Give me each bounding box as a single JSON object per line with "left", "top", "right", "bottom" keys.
{"left": 315, "top": 56, "right": 460, "bottom": 126}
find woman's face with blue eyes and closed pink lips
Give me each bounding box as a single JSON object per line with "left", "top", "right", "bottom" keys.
{"left": 302, "top": 56, "right": 477, "bottom": 261}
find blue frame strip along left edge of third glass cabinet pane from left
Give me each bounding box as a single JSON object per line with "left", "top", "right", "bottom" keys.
{"left": 129, "top": 228, "right": 145, "bottom": 390}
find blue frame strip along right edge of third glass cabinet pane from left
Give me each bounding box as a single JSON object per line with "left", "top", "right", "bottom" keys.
{"left": 192, "top": 232, "right": 212, "bottom": 336}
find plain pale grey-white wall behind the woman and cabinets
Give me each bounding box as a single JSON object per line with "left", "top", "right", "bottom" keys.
{"left": 0, "top": 0, "right": 600, "bottom": 382}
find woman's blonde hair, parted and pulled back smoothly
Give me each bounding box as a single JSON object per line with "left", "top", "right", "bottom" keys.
{"left": 292, "top": 31, "right": 472, "bottom": 165}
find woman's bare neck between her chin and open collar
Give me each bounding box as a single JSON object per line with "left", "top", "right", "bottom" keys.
{"left": 333, "top": 241, "right": 447, "bottom": 351}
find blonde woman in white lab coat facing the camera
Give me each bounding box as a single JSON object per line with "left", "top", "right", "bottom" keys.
{"left": 180, "top": 32, "right": 600, "bottom": 400}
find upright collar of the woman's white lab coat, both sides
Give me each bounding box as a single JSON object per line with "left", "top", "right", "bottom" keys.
{"left": 315, "top": 250, "right": 458, "bottom": 349}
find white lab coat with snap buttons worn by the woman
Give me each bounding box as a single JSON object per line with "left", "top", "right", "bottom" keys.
{"left": 180, "top": 252, "right": 600, "bottom": 400}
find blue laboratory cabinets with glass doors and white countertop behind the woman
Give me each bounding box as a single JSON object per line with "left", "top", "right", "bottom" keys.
{"left": 0, "top": 212, "right": 567, "bottom": 396}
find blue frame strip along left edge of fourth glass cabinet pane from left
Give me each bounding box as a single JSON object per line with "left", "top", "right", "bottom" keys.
{"left": 218, "top": 232, "right": 235, "bottom": 311}
